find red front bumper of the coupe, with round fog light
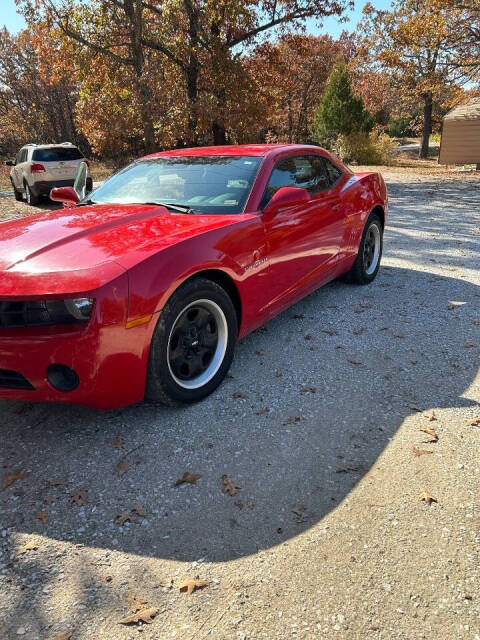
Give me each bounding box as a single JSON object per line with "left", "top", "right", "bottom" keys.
{"left": 0, "top": 277, "right": 156, "bottom": 409}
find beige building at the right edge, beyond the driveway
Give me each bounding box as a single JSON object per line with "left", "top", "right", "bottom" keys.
{"left": 438, "top": 98, "right": 480, "bottom": 165}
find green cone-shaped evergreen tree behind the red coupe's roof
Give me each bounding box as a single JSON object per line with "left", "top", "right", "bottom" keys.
{"left": 312, "top": 63, "right": 373, "bottom": 148}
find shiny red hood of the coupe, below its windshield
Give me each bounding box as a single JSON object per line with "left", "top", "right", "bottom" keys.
{"left": 0, "top": 204, "right": 243, "bottom": 296}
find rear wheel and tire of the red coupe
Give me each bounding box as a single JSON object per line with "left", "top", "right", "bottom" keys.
{"left": 343, "top": 213, "right": 383, "bottom": 284}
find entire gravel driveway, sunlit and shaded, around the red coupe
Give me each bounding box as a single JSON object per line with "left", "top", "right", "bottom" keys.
{"left": 0, "top": 170, "right": 480, "bottom": 640}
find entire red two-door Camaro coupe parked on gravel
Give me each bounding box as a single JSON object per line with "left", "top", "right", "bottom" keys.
{"left": 0, "top": 145, "right": 387, "bottom": 409}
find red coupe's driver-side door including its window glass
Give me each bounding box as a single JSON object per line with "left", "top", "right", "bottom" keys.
{"left": 262, "top": 154, "right": 344, "bottom": 313}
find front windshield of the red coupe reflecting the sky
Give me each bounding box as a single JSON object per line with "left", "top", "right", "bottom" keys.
{"left": 92, "top": 156, "right": 261, "bottom": 213}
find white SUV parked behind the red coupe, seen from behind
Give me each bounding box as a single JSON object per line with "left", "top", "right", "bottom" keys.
{"left": 5, "top": 142, "right": 92, "bottom": 205}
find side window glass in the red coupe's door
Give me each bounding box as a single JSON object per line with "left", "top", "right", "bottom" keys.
{"left": 261, "top": 155, "right": 329, "bottom": 208}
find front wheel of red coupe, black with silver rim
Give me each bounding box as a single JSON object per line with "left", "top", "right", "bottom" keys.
{"left": 145, "top": 278, "right": 238, "bottom": 406}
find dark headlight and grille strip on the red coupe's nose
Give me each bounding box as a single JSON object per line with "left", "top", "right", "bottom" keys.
{"left": 0, "top": 298, "right": 93, "bottom": 328}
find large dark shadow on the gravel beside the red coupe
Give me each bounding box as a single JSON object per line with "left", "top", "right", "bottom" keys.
{"left": 0, "top": 267, "right": 480, "bottom": 561}
